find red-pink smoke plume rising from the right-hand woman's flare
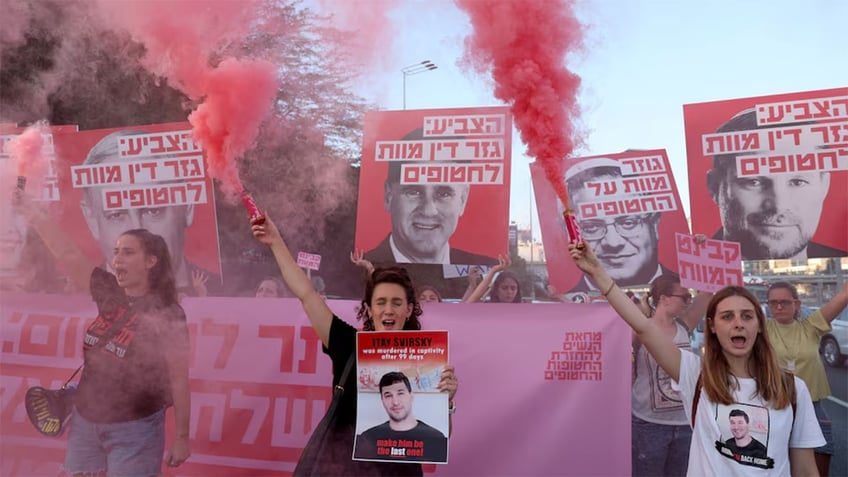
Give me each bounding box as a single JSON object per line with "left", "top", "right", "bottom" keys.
{"left": 455, "top": 0, "right": 583, "bottom": 208}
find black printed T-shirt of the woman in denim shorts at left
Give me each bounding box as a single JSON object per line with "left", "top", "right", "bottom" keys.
{"left": 74, "top": 271, "right": 188, "bottom": 423}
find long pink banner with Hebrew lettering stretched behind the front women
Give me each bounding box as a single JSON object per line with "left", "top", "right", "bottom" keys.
{"left": 0, "top": 294, "right": 630, "bottom": 476}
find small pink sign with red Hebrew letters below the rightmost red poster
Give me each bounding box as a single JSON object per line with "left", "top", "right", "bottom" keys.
{"left": 674, "top": 233, "right": 743, "bottom": 292}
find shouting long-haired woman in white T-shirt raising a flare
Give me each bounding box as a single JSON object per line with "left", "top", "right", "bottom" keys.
{"left": 568, "top": 242, "right": 825, "bottom": 476}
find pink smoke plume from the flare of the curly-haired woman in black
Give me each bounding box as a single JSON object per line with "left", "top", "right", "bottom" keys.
{"left": 93, "top": 0, "right": 278, "bottom": 200}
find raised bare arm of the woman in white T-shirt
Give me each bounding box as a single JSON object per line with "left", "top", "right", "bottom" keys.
{"left": 568, "top": 242, "right": 680, "bottom": 381}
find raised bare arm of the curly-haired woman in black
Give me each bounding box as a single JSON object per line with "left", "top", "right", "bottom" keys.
{"left": 251, "top": 217, "right": 333, "bottom": 346}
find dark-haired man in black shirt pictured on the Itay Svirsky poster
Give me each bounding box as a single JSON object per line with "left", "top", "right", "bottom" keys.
{"left": 354, "top": 371, "right": 448, "bottom": 462}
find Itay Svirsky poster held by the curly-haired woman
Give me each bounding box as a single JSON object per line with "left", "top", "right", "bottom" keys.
{"left": 353, "top": 331, "right": 450, "bottom": 464}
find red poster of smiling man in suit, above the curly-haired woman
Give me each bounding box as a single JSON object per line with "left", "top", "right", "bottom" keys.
{"left": 355, "top": 107, "right": 512, "bottom": 265}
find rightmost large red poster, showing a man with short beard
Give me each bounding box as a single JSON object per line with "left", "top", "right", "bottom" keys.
{"left": 683, "top": 88, "right": 848, "bottom": 260}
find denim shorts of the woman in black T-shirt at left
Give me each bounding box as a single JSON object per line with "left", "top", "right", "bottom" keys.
{"left": 64, "top": 409, "right": 165, "bottom": 477}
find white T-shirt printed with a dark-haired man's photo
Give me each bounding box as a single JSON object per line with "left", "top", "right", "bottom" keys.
{"left": 675, "top": 351, "right": 825, "bottom": 477}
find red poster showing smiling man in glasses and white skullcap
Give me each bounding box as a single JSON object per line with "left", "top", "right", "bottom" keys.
{"left": 530, "top": 149, "right": 689, "bottom": 293}
